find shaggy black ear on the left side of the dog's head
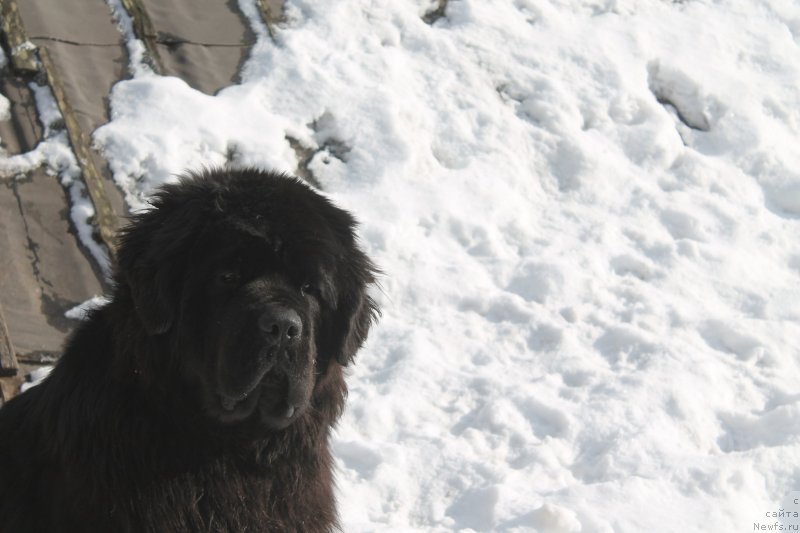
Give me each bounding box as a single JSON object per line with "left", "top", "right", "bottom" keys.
{"left": 116, "top": 186, "right": 203, "bottom": 335}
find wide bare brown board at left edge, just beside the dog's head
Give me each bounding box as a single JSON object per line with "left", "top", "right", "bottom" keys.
{"left": 0, "top": 166, "right": 104, "bottom": 358}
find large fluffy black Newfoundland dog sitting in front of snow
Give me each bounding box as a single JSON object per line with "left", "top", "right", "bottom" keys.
{"left": 0, "top": 170, "right": 378, "bottom": 533}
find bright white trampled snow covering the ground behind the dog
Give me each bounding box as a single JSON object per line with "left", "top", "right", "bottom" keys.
{"left": 1, "top": 0, "right": 800, "bottom": 532}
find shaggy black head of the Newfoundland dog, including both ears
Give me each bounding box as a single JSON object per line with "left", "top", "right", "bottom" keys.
{"left": 116, "top": 170, "right": 377, "bottom": 429}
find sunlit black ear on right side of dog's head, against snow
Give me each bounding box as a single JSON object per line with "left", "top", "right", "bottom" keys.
{"left": 327, "top": 251, "right": 380, "bottom": 366}
